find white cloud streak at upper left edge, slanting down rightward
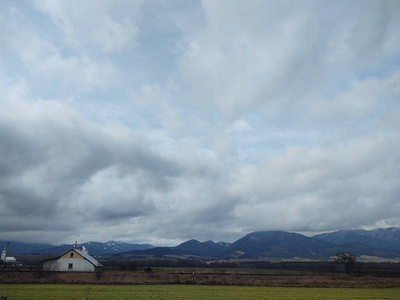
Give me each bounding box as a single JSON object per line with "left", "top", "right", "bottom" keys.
{"left": 0, "top": 3, "right": 120, "bottom": 94}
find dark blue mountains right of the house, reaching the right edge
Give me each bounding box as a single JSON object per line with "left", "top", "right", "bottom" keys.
{"left": 121, "top": 228, "right": 400, "bottom": 259}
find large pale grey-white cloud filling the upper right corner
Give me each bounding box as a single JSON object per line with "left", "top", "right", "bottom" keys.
{"left": 179, "top": 1, "right": 400, "bottom": 116}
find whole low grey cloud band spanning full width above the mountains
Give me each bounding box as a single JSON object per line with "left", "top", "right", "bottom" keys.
{"left": 0, "top": 90, "right": 400, "bottom": 243}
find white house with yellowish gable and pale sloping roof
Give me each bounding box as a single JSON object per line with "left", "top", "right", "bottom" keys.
{"left": 43, "top": 248, "right": 103, "bottom": 272}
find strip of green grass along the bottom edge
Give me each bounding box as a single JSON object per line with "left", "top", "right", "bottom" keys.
{"left": 0, "top": 284, "right": 400, "bottom": 300}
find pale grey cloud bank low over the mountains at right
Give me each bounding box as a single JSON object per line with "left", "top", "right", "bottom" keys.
{"left": 230, "top": 131, "right": 400, "bottom": 231}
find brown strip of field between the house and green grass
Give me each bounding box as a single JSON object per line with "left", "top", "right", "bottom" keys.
{"left": 0, "top": 271, "right": 400, "bottom": 288}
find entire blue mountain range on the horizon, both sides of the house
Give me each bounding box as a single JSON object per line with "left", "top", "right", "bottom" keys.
{"left": 0, "top": 227, "right": 400, "bottom": 259}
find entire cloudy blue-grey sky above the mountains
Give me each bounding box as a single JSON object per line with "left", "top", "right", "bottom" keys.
{"left": 0, "top": 0, "right": 400, "bottom": 245}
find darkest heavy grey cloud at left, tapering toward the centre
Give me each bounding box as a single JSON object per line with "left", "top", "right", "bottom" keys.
{"left": 0, "top": 95, "right": 179, "bottom": 240}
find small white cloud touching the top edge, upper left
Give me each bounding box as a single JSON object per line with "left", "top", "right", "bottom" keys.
{"left": 35, "top": 0, "right": 142, "bottom": 53}
